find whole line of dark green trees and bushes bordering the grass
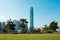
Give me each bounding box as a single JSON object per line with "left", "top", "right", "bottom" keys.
{"left": 0, "top": 19, "right": 59, "bottom": 34}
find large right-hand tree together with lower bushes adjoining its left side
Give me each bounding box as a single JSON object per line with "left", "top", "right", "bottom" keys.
{"left": 43, "top": 21, "right": 59, "bottom": 33}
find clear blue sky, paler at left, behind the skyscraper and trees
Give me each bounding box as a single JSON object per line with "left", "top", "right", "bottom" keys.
{"left": 0, "top": 0, "right": 60, "bottom": 28}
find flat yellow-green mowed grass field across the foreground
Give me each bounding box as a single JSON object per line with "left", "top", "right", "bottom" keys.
{"left": 0, "top": 34, "right": 60, "bottom": 40}
